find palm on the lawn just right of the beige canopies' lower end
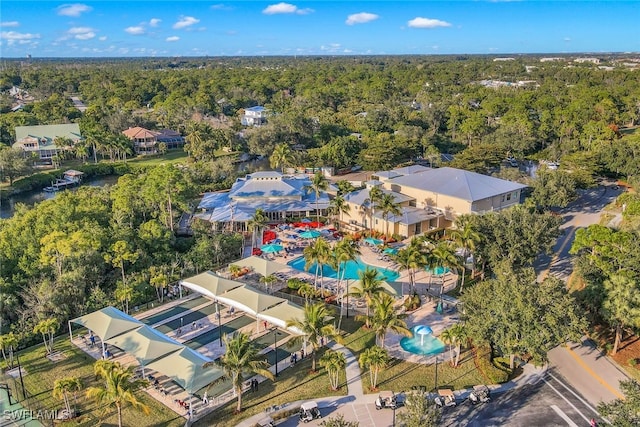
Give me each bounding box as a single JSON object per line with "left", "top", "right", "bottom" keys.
{"left": 287, "top": 302, "right": 342, "bottom": 372}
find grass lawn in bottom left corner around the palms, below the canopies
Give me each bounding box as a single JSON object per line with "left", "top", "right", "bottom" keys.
{"left": 2, "top": 337, "right": 185, "bottom": 427}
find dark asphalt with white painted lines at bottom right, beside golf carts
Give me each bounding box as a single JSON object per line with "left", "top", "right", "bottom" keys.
{"left": 441, "top": 369, "right": 605, "bottom": 427}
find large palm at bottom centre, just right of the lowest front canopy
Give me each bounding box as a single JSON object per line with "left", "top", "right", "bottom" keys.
{"left": 212, "top": 332, "right": 275, "bottom": 412}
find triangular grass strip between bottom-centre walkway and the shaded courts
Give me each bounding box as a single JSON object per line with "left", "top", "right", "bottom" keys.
{"left": 194, "top": 350, "right": 347, "bottom": 427}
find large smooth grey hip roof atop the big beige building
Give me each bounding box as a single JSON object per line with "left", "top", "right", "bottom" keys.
{"left": 389, "top": 167, "right": 527, "bottom": 202}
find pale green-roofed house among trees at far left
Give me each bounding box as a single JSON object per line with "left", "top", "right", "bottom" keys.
{"left": 13, "top": 123, "right": 83, "bottom": 163}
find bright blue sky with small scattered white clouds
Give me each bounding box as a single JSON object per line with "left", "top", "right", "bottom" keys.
{"left": 0, "top": 0, "right": 640, "bottom": 58}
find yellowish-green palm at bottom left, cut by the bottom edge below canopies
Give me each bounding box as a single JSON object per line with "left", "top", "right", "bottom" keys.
{"left": 86, "top": 360, "right": 150, "bottom": 427}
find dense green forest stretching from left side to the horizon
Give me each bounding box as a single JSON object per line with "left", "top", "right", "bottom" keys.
{"left": 0, "top": 56, "right": 640, "bottom": 348}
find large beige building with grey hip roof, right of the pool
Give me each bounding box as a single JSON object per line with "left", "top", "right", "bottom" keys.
{"left": 341, "top": 165, "right": 526, "bottom": 237}
